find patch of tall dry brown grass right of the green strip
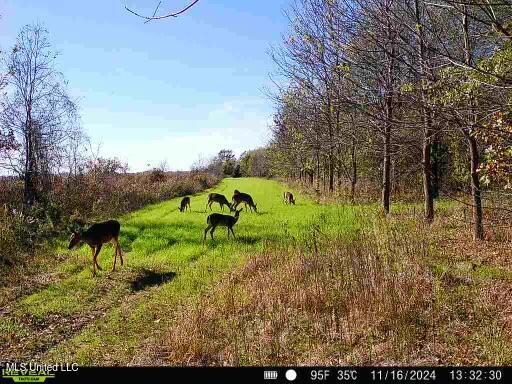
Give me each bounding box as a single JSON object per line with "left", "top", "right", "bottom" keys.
{"left": 158, "top": 221, "right": 434, "bottom": 365}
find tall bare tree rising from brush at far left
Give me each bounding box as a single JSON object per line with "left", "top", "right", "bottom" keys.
{"left": 1, "top": 25, "right": 80, "bottom": 205}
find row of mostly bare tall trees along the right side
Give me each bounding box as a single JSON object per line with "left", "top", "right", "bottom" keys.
{"left": 269, "top": 0, "right": 512, "bottom": 240}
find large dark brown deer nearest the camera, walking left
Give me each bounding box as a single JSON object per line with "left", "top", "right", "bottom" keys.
{"left": 68, "top": 220, "right": 123, "bottom": 276}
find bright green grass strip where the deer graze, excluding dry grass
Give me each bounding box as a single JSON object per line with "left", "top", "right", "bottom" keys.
{"left": 0, "top": 178, "right": 360, "bottom": 365}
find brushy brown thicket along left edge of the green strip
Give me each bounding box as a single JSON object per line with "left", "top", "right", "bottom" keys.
{"left": 0, "top": 170, "right": 218, "bottom": 268}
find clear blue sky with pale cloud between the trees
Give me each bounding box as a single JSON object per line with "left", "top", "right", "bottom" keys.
{"left": 0, "top": 0, "right": 288, "bottom": 171}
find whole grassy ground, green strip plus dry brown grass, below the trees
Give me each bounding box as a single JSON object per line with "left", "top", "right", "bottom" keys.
{"left": 0, "top": 178, "right": 512, "bottom": 365}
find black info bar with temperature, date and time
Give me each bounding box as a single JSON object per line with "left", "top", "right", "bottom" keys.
{"left": 0, "top": 363, "right": 506, "bottom": 384}
